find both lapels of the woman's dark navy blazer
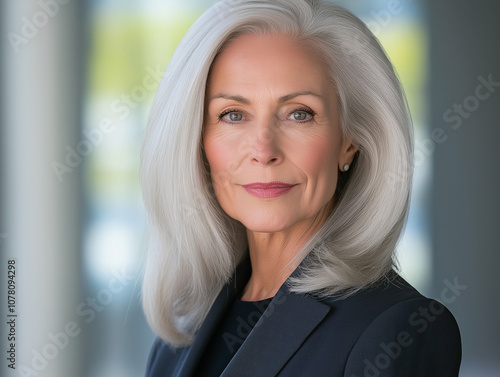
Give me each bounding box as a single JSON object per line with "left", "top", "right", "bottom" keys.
{"left": 178, "top": 253, "right": 331, "bottom": 377}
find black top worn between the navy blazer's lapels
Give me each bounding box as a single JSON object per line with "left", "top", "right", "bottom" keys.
{"left": 195, "top": 298, "right": 272, "bottom": 377}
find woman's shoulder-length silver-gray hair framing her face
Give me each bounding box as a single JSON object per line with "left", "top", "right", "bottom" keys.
{"left": 141, "top": 0, "right": 413, "bottom": 346}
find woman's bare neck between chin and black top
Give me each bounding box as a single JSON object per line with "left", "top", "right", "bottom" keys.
{"left": 241, "top": 210, "right": 326, "bottom": 301}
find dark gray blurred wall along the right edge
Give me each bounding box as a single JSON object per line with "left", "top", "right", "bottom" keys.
{"left": 427, "top": 0, "right": 500, "bottom": 377}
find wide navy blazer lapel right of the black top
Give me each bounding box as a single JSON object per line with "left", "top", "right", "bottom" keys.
{"left": 221, "top": 268, "right": 331, "bottom": 377}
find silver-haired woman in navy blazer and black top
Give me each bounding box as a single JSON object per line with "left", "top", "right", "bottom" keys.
{"left": 142, "top": 0, "right": 461, "bottom": 377}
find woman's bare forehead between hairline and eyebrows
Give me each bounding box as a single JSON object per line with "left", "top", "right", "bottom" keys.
{"left": 208, "top": 34, "right": 328, "bottom": 96}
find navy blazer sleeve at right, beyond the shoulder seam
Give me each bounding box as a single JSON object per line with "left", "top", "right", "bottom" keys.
{"left": 345, "top": 297, "right": 462, "bottom": 377}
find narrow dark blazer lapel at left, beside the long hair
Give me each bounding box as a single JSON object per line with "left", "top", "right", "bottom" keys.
{"left": 175, "top": 253, "right": 251, "bottom": 377}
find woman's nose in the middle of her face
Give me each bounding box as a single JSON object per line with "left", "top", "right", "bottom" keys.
{"left": 250, "top": 123, "right": 283, "bottom": 165}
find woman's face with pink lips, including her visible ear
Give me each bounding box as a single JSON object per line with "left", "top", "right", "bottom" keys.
{"left": 204, "top": 34, "right": 356, "bottom": 233}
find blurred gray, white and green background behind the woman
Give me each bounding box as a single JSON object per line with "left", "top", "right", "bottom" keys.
{"left": 0, "top": 0, "right": 500, "bottom": 377}
